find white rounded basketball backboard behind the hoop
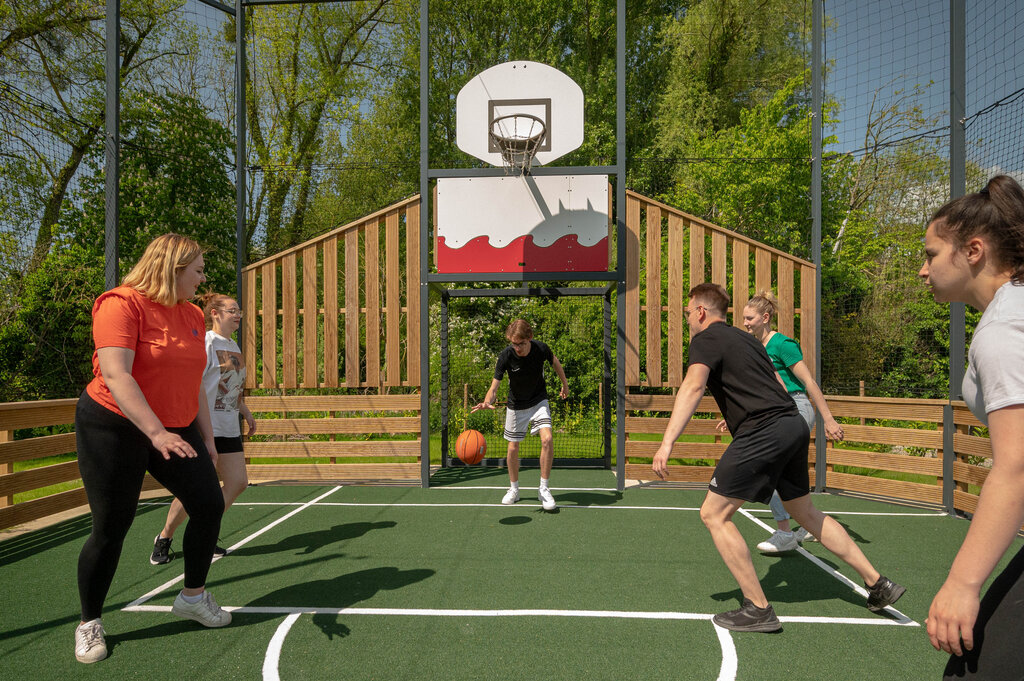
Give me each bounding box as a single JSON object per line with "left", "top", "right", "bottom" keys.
{"left": 456, "top": 61, "right": 583, "bottom": 166}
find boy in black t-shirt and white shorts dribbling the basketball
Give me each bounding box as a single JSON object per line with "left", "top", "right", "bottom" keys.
{"left": 472, "top": 320, "right": 569, "bottom": 511}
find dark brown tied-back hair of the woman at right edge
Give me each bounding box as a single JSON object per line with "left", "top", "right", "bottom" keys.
{"left": 930, "top": 175, "right": 1024, "bottom": 285}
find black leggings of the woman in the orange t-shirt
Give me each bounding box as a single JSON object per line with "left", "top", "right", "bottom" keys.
{"left": 75, "top": 392, "right": 224, "bottom": 622}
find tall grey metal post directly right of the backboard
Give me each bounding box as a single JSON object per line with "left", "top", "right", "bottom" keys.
{"left": 615, "top": 0, "right": 626, "bottom": 492}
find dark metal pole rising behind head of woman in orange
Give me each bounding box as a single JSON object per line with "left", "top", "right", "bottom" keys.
{"left": 103, "top": 0, "right": 121, "bottom": 290}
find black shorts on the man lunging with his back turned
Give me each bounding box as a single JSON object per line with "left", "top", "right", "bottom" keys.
{"left": 708, "top": 412, "right": 811, "bottom": 504}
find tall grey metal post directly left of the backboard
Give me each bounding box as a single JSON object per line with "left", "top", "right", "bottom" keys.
{"left": 420, "top": 0, "right": 430, "bottom": 487}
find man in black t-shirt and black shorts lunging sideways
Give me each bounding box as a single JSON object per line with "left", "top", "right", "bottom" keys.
{"left": 652, "top": 284, "right": 905, "bottom": 632}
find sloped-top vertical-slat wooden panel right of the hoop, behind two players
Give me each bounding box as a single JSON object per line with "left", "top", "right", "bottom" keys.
{"left": 624, "top": 191, "right": 817, "bottom": 387}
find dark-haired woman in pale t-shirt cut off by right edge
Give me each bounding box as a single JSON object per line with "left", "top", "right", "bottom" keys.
{"left": 919, "top": 175, "right": 1024, "bottom": 679}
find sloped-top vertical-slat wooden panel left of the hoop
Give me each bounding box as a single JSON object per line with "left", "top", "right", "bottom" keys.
{"left": 241, "top": 196, "right": 420, "bottom": 388}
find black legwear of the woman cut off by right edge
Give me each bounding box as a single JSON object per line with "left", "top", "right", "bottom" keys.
{"left": 942, "top": 549, "right": 1024, "bottom": 681}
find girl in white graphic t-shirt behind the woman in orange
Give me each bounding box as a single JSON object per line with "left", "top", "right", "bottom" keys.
{"left": 150, "top": 293, "right": 256, "bottom": 565}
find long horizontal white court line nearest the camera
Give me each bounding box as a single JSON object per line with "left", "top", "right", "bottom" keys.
{"left": 124, "top": 605, "right": 921, "bottom": 627}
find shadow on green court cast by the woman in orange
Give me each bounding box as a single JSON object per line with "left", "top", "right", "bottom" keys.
{"left": 248, "top": 567, "right": 435, "bottom": 640}
